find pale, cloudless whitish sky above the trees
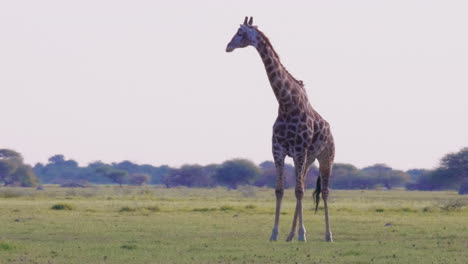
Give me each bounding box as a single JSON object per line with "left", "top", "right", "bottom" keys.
{"left": 0, "top": 0, "right": 468, "bottom": 169}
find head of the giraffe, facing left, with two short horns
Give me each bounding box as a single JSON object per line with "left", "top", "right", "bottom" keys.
{"left": 226, "top": 17, "right": 259, "bottom": 52}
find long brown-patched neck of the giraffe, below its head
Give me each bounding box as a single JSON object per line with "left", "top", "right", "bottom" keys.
{"left": 256, "top": 34, "right": 309, "bottom": 112}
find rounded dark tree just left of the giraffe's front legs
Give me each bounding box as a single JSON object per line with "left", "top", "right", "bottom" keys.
{"left": 214, "top": 159, "right": 261, "bottom": 189}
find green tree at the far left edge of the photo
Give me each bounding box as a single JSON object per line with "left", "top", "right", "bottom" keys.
{"left": 0, "top": 149, "right": 37, "bottom": 187}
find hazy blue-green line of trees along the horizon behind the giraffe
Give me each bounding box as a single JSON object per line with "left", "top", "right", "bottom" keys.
{"left": 0, "top": 148, "right": 468, "bottom": 193}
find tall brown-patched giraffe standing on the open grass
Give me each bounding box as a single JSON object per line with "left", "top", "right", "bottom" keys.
{"left": 226, "top": 17, "right": 335, "bottom": 242}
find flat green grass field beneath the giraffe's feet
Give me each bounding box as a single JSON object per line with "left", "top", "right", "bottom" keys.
{"left": 0, "top": 186, "right": 468, "bottom": 264}
